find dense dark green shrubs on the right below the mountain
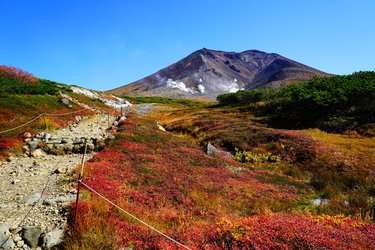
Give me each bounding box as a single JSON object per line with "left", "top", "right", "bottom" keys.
{"left": 218, "top": 72, "right": 375, "bottom": 136}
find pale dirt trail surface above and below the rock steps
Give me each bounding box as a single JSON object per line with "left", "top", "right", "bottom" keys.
{"left": 0, "top": 115, "right": 114, "bottom": 249}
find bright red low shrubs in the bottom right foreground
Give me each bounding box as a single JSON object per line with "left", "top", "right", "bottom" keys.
{"left": 205, "top": 214, "right": 375, "bottom": 249}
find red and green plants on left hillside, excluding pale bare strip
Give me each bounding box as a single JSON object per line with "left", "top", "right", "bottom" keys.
{"left": 0, "top": 65, "right": 91, "bottom": 160}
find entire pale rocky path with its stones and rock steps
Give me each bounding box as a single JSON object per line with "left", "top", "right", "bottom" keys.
{"left": 0, "top": 114, "right": 114, "bottom": 249}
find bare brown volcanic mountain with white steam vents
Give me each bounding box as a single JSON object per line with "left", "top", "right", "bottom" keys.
{"left": 108, "top": 48, "right": 327, "bottom": 98}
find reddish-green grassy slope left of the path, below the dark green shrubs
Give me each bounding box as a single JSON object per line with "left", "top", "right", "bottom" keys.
{"left": 0, "top": 92, "right": 122, "bottom": 159}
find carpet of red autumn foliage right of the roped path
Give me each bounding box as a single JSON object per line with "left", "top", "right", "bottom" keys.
{"left": 73, "top": 116, "right": 375, "bottom": 249}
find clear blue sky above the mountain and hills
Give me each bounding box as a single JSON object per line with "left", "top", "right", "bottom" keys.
{"left": 0, "top": 0, "right": 375, "bottom": 90}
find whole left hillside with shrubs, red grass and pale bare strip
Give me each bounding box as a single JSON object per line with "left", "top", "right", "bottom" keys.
{"left": 0, "top": 65, "right": 131, "bottom": 160}
